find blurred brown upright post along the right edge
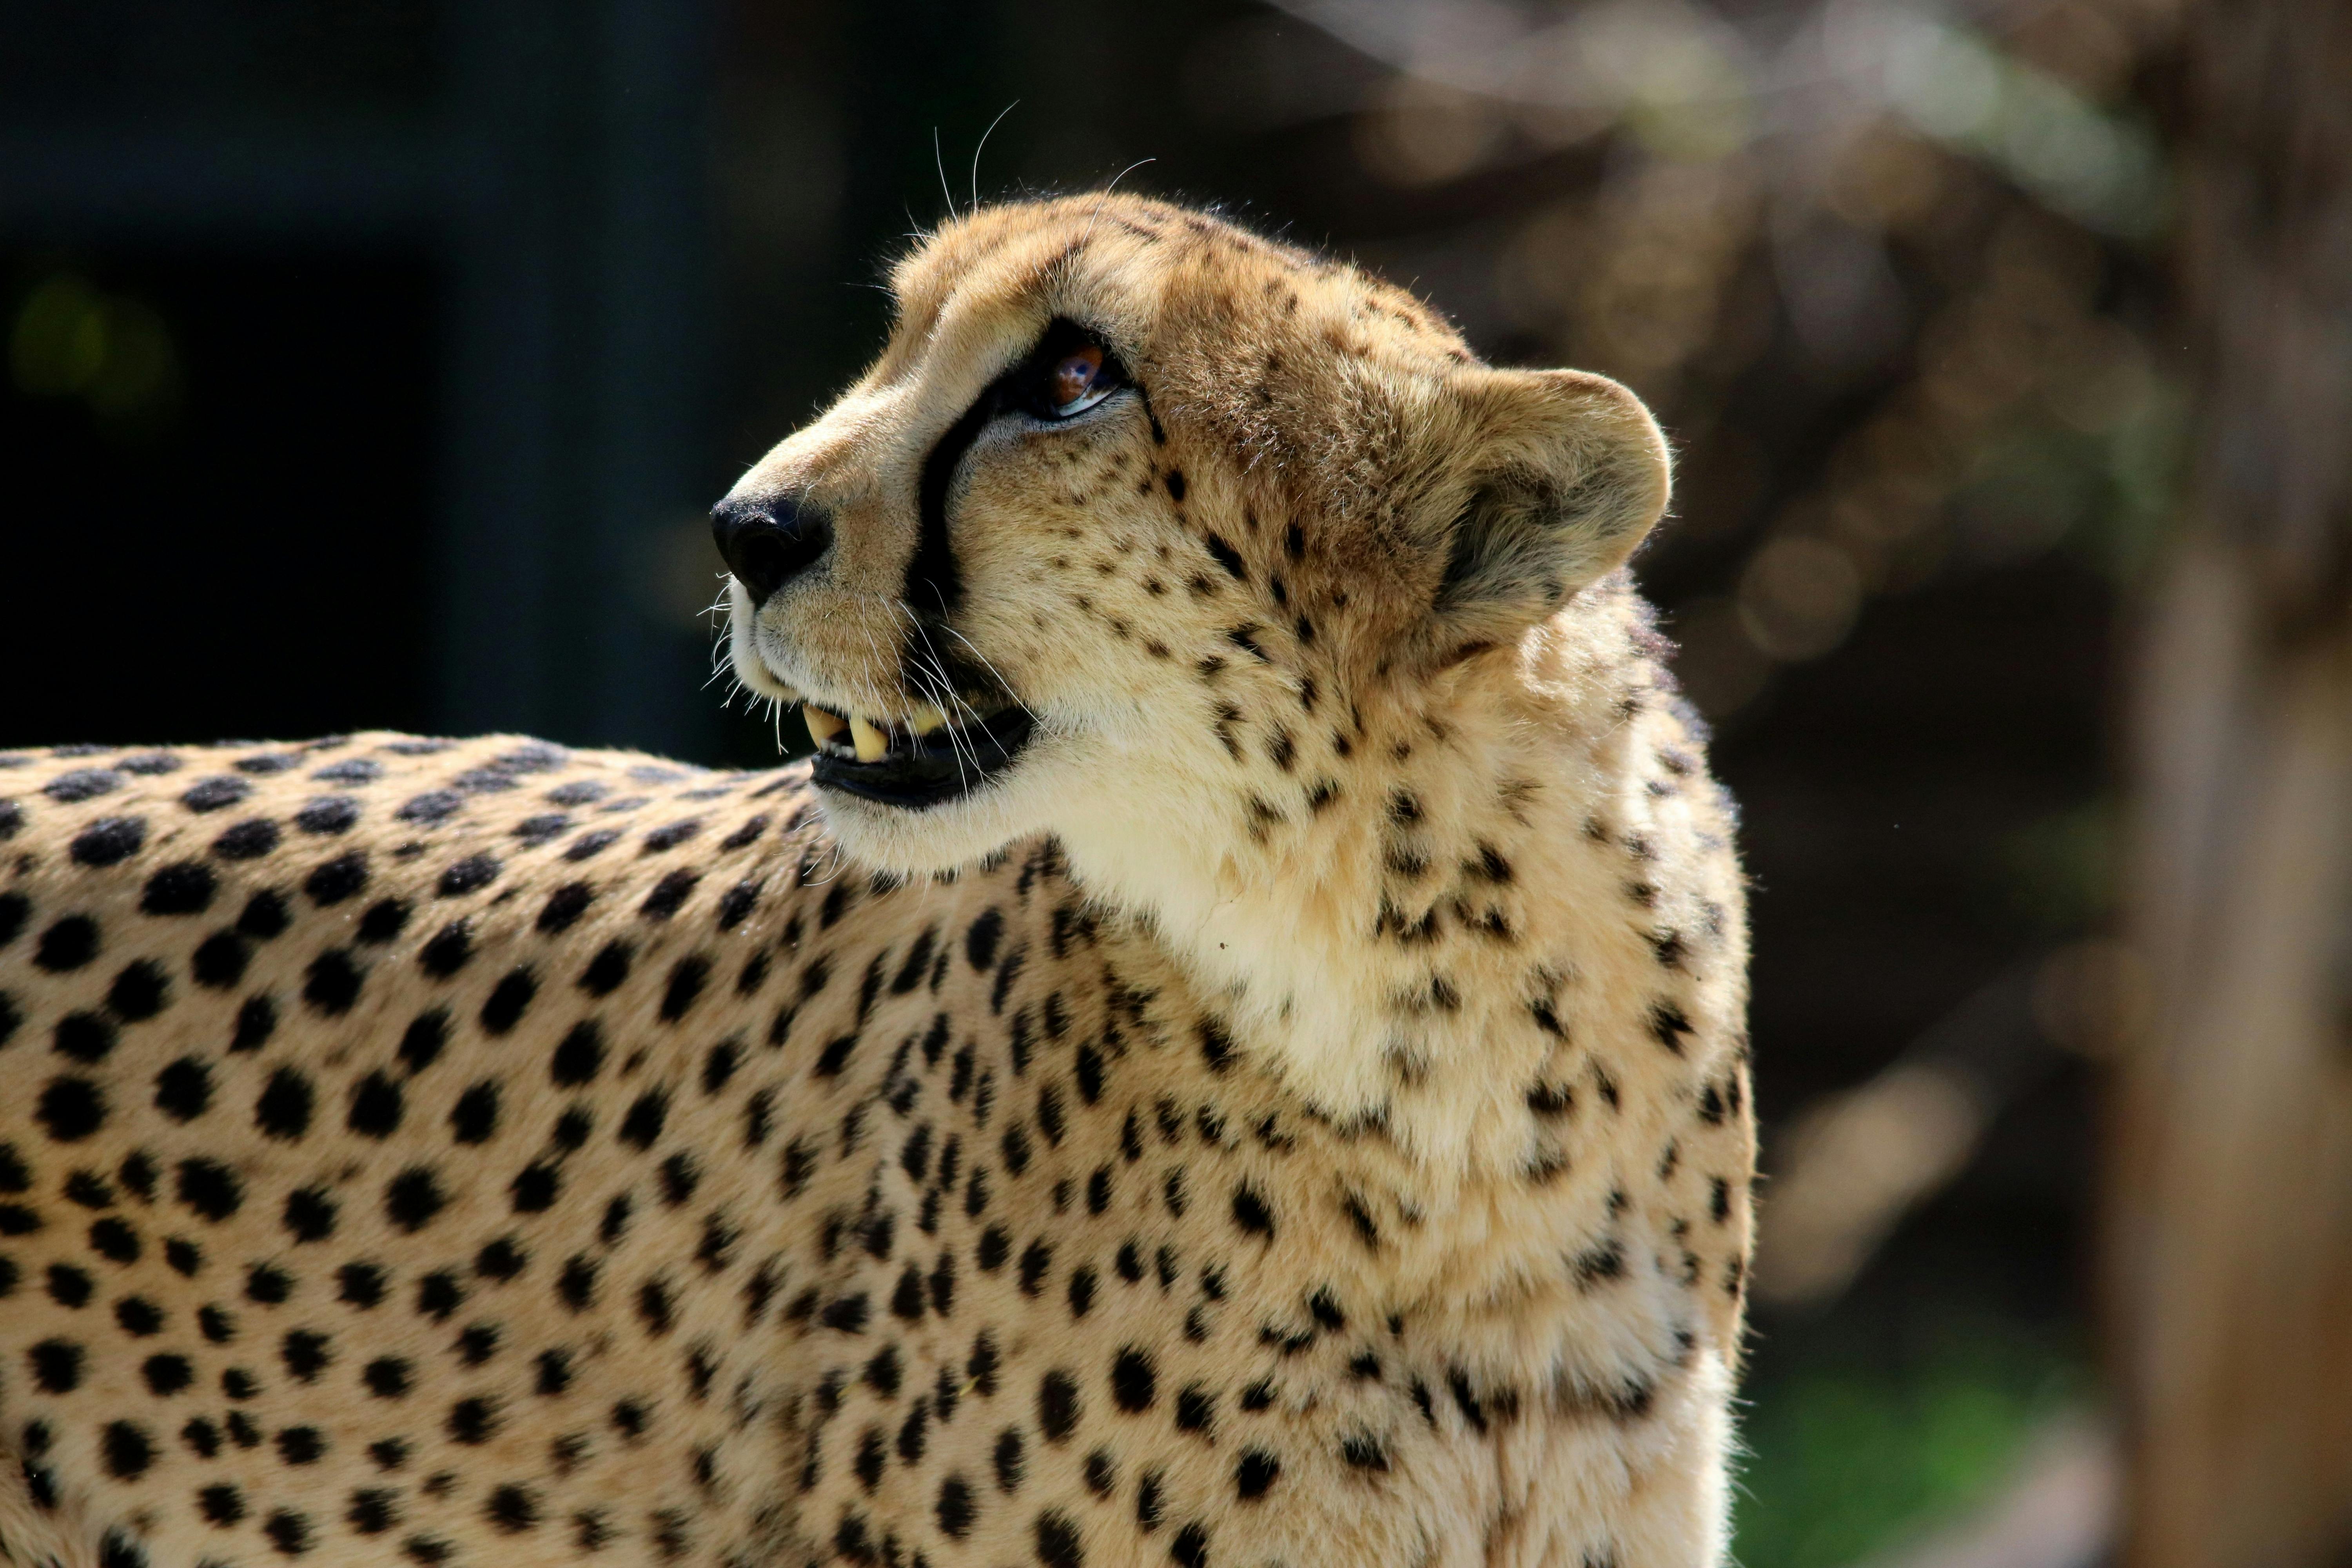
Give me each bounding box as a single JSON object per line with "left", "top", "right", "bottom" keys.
{"left": 2105, "top": 0, "right": 2352, "bottom": 1568}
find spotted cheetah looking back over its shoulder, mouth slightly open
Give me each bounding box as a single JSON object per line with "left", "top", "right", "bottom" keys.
{"left": 0, "top": 195, "right": 1752, "bottom": 1568}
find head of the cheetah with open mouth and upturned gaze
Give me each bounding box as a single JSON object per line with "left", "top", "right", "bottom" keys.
{"left": 713, "top": 195, "right": 1668, "bottom": 872}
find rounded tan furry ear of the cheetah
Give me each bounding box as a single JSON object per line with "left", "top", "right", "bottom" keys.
{"left": 1430, "top": 369, "right": 1670, "bottom": 646}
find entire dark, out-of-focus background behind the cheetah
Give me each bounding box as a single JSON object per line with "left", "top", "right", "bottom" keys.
{"left": 0, "top": 0, "right": 2352, "bottom": 1568}
